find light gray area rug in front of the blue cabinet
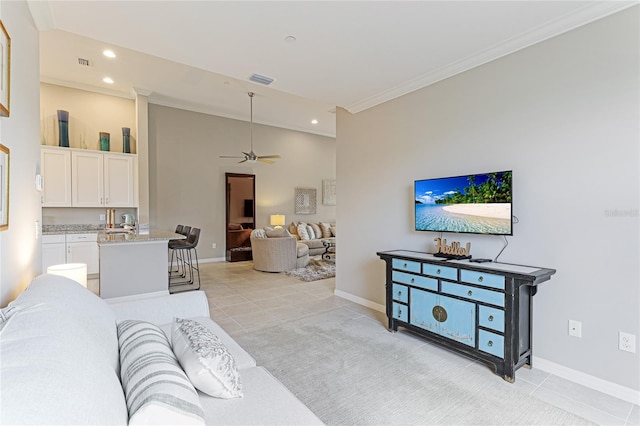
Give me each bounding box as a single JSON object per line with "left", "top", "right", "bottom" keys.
{"left": 235, "top": 309, "right": 591, "bottom": 425}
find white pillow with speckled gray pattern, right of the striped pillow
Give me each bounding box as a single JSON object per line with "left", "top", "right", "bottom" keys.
{"left": 171, "top": 318, "right": 242, "bottom": 398}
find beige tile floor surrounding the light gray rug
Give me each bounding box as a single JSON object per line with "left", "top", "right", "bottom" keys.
{"left": 182, "top": 262, "right": 640, "bottom": 425}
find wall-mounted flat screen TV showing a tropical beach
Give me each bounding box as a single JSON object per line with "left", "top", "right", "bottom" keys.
{"left": 414, "top": 171, "right": 513, "bottom": 235}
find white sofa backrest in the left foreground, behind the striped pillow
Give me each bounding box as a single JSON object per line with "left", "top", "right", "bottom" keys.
{"left": 0, "top": 275, "right": 128, "bottom": 425}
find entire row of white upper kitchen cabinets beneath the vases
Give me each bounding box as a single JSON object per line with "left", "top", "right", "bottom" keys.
{"left": 41, "top": 147, "right": 136, "bottom": 207}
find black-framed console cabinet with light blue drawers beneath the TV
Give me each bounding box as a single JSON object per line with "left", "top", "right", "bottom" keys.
{"left": 377, "top": 250, "right": 556, "bottom": 383}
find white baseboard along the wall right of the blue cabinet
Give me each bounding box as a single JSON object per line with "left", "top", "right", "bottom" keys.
{"left": 533, "top": 357, "right": 640, "bottom": 405}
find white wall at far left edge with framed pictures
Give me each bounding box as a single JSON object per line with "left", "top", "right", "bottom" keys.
{"left": 0, "top": 1, "right": 40, "bottom": 306}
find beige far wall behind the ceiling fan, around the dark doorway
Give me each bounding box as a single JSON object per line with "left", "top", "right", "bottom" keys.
{"left": 149, "top": 104, "right": 336, "bottom": 259}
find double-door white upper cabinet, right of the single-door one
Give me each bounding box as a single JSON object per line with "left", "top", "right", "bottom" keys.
{"left": 71, "top": 151, "right": 134, "bottom": 207}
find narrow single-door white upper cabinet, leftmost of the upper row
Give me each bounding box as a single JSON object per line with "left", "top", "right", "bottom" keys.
{"left": 40, "top": 148, "right": 71, "bottom": 207}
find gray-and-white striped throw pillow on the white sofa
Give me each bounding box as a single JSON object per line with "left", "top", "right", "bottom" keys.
{"left": 118, "top": 320, "right": 205, "bottom": 425}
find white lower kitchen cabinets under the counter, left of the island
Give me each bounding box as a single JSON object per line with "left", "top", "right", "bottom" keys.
{"left": 42, "top": 233, "right": 100, "bottom": 274}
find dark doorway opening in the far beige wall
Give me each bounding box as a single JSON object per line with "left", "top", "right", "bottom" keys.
{"left": 225, "top": 173, "right": 256, "bottom": 262}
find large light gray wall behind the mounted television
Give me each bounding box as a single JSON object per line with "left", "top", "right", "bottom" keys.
{"left": 336, "top": 7, "right": 640, "bottom": 390}
